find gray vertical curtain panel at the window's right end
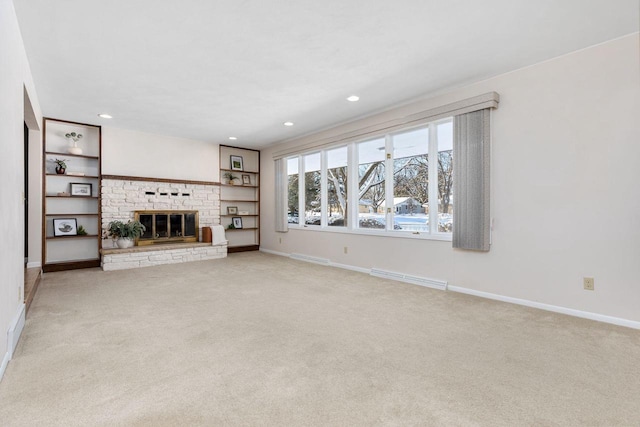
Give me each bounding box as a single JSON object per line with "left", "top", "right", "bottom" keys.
{"left": 453, "top": 108, "right": 490, "bottom": 251}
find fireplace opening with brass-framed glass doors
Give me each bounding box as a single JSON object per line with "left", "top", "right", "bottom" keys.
{"left": 134, "top": 210, "right": 198, "bottom": 246}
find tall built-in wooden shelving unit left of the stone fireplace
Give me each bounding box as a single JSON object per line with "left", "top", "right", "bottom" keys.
{"left": 42, "top": 118, "right": 102, "bottom": 272}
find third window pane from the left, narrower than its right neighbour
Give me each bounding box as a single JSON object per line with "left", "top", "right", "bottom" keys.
{"left": 327, "top": 147, "right": 348, "bottom": 227}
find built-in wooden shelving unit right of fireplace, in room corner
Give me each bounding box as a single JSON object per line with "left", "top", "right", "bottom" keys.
{"left": 220, "top": 145, "right": 260, "bottom": 253}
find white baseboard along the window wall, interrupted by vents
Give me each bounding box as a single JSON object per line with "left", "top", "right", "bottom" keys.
{"left": 260, "top": 248, "right": 640, "bottom": 329}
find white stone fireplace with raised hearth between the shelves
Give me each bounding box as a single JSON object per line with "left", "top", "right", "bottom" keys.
{"left": 100, "top": 175, "right": 227, "bottom": 270}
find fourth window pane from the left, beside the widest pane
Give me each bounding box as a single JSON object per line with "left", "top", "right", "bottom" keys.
{"left": 358, "top": 138, "right": 385, "bottom": 228}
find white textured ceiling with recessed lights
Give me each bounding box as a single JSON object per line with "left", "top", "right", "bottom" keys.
{"left": 14, "top": 0, "right": 639, "bottom": 148}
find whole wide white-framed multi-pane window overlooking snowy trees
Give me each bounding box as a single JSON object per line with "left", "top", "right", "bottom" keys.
{"left": 287, "top": 118, "right": 454, "bottom": 239}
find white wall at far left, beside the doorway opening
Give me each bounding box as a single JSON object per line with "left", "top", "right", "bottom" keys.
{"left": 0, "top": 0, "right": 42, "bottom": 375}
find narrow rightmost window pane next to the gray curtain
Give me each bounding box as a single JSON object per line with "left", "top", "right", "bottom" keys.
{"left": 437, "top": 121, "right": 453, "bottom": 233}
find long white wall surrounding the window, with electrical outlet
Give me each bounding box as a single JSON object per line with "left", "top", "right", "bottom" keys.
{"left": 261, "top": 34, "right": 640, "bottom": 322}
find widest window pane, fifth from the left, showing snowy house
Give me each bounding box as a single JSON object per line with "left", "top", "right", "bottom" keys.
{"left": 385, "top": 128, "right": 429, "bottom": 232}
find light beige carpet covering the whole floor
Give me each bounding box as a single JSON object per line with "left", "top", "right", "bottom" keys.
{"left": 0, "top": 253, "right": 640, "bottom": 426}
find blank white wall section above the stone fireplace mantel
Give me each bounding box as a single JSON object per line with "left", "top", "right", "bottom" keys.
{"left": 102, "top": 126, "right": 220, "bottom": 181}
